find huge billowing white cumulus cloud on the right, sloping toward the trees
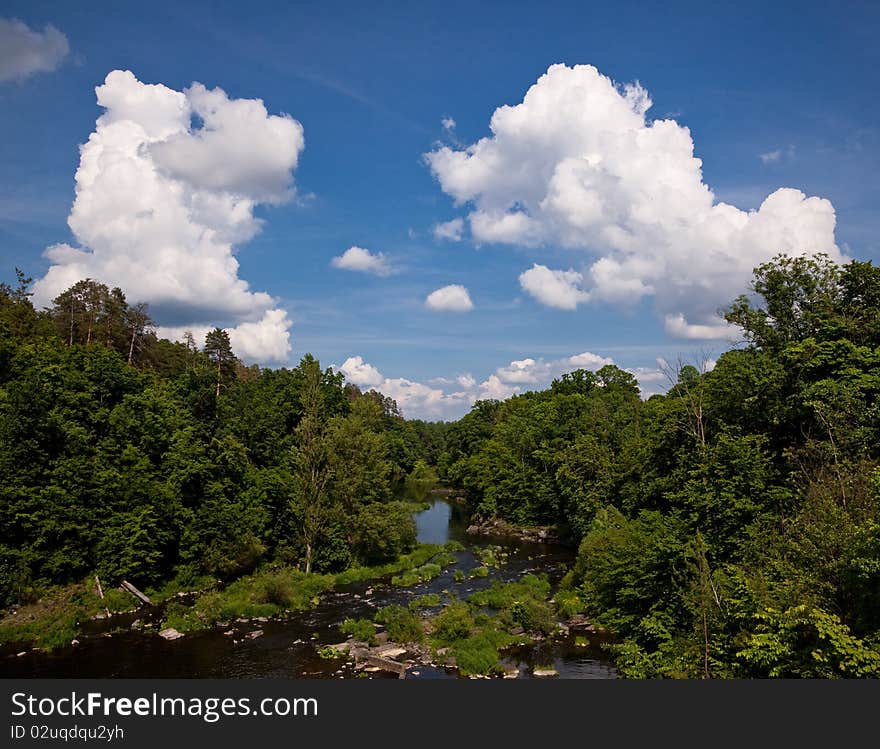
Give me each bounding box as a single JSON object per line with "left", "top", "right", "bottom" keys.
{"left": 425, "top": 65, "right": 842, "bottom": 338}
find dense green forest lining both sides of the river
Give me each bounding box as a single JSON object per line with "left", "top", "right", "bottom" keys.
{"left": 0, "top": 256, "right": 880, "bottom": 678}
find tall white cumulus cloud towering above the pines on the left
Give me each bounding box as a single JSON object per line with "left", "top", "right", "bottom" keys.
{"left": 34, "top": 70, "right": 304, "bottom": 361}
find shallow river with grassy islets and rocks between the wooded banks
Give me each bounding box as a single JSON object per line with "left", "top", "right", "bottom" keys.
{"left": 2, "top": 499, "right": 616, "bottom": 679}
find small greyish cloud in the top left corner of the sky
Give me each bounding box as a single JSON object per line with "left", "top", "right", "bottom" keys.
{"left": 0, "top": 18, "right": 70, "bottom": 81}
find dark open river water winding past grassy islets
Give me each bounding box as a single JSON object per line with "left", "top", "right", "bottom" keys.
{"left": 0, "top": 499, "right": 617, "bottom": 679}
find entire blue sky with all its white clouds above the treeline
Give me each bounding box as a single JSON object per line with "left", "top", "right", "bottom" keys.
{"left": 0, "top": 0, "right": 880, "bottom": 419}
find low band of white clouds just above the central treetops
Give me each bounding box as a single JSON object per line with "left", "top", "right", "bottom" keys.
{"left": 334, "top": 351, "right": 620, "bottom": 420}
